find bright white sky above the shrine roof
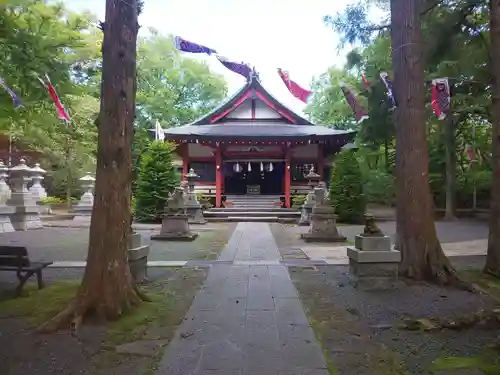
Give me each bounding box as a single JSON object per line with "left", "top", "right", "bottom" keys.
{"left": 64, "top": 0, "right": 351, "bottom": 114}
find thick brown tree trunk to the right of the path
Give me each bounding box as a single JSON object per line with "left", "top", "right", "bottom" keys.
{"left": 391, "top": 0, "right": 456, "bottom": 284}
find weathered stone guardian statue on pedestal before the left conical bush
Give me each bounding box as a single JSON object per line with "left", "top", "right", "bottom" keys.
{"left": 151, "top": 187, "right": 198, "bottom": 241}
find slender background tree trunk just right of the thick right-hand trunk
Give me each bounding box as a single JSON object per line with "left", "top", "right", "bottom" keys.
{"left": 443, "top": 114, "right": 457, "bottom": 221}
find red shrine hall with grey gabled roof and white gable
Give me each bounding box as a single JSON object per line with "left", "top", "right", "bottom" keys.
{"left": 165, "top": 74, "right": 355, "bottom": 207}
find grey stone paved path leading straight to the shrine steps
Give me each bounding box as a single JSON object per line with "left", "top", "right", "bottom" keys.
{"left": 156, "top": 223, "right": 329, "bottom": 375}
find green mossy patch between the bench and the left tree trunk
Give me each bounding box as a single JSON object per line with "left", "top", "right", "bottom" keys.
{"left": 0, "top": 280, "right": 80, "bottom": 326}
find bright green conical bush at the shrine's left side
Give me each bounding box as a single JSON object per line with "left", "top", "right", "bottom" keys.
{"left": 135, "top": 142, "right": 179, "bottom": 221}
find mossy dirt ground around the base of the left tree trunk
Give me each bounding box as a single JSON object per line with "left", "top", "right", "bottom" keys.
{"left": 0, "top": 268, "right": 206, "bottom": 375}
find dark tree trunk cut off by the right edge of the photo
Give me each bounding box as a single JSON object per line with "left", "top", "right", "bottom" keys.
{"left": 484, "top": 0, "right": 500, "bottom": 277}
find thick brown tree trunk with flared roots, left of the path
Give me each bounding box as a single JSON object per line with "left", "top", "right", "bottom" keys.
{"left": 42, "top": 0, "right": 143, "bottom": 330}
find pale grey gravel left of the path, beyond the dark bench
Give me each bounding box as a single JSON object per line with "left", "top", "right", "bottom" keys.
{"left": 0, "top": 223, "right": 235, "bottom": 261}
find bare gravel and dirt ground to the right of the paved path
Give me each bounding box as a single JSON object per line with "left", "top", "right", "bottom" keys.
{"left": 271, "top": 221, "right": 500, "bottom": 375}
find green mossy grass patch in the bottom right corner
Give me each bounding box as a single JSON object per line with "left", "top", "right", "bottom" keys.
{"left": 431, "top": 353, "right": 500, "bottom": 375}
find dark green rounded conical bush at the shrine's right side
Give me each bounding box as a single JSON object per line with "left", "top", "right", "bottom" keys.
{"left": 329, "top": 150, "right": 366, "bottom": 223}
